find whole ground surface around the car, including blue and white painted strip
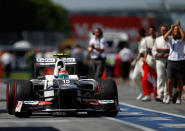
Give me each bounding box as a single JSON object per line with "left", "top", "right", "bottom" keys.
{"left": 0, "top": 79, "right": 185, "bottom": 131}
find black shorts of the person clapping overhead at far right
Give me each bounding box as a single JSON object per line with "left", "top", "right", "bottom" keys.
{"left": 167, "top": 60, "right": 185, "bottom": 78}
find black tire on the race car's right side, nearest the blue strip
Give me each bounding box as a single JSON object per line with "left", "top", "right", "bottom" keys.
{"left": 99, "top": 79, "right": 119, "bottom": 117}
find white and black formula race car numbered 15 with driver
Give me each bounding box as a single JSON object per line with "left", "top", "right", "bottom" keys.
{"left": 7, "top": 54, "right": 119, "bottom": 117}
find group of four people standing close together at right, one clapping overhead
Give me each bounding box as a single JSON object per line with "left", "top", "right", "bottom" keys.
{"left": 127, "top": 20, "right": 185, "bottom": 104}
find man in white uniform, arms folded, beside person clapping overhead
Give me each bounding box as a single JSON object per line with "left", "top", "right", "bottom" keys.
{"left": 152, "top": 25, "right": 169, "bottom": 101}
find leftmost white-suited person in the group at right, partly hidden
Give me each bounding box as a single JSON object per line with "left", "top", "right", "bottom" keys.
{"left": 131, "top": 29, "right": 146, "bottom": 100}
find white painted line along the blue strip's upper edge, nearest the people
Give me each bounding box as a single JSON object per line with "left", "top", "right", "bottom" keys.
{"left": 120, "top": 102, "right": 185, "bottom": 118}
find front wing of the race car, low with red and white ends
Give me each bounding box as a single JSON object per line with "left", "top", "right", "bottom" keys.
{"left": 15, "top": 100, "right": 119, "bottom": 113}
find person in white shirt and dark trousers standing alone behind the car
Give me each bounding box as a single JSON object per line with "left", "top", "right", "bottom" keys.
{"left": 88, "top": 28, "right": 106, "bottom": 78}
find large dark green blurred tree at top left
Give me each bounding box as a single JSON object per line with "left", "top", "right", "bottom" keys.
{"left": 0, "top": 0, "right": 69, "bottom": 32}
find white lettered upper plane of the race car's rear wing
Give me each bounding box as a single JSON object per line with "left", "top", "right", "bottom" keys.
{"left": 35, "top": 58, "right": 76, "bottom": 66}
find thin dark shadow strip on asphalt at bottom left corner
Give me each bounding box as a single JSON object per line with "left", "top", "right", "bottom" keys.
{"left": 0, "top": 127, "right": 60, "bottom": 131}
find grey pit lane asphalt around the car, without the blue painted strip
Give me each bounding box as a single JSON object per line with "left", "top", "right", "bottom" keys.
{"left": 0, "top": 79, "right": 185, "bottom": 131}
